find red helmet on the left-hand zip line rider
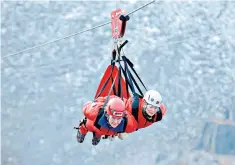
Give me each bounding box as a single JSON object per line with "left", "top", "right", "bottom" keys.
{"left": 107, "top": 98, "right": 126, "bottom": 118}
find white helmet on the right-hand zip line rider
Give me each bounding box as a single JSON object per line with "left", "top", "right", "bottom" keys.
{"left": 144, "top": 90, "right": 162, "bottom": 107}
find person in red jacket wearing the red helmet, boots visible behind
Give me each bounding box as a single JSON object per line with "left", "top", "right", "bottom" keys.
{"left": 77, "top": 96, "right": 137, "bottom": 145}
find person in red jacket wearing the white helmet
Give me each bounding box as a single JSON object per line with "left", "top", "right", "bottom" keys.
{"left": 126, "top": 90, "right": 166, "bottom": 129}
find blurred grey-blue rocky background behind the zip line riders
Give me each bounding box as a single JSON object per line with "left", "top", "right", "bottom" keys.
{"left": 1, "top": 0, "right": 235, "bottom": 165}
